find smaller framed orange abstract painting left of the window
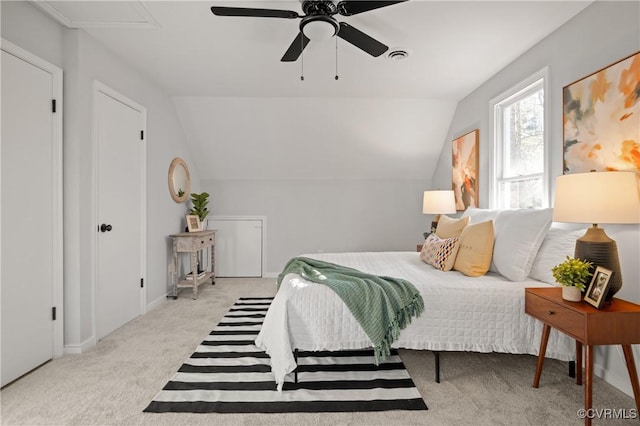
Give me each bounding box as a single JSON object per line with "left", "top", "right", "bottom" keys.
{"left": 451, "top": 129, "right": 479, "bottom": 211}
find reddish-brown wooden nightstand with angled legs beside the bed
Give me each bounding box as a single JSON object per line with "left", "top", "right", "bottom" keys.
{"left": 524, "top": 287, "right": 640, "bottom": 425}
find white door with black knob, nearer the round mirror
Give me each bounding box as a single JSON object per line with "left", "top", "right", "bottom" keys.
{"left": 94, "top": 83, "right": 146, "bottom": 339}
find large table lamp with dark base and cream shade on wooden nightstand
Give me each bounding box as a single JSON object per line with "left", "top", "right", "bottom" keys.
{"left": 553, "top": 172, "right": 640, "bottom": 301}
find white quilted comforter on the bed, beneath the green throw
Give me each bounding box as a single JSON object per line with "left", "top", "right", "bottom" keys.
{"left": 256, "top": 252, "right": 575, "bottom": 389}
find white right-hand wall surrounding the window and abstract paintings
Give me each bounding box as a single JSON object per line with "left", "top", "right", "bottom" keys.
{"left": 432, "top": 2, "right": 640, "bottom": 395}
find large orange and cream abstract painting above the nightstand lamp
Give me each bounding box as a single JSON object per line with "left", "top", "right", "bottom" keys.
{"left": 562, "top": 52, "right": 640, "bottom": 174}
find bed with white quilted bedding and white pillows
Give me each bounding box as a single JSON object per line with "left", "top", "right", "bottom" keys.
{"left": 256, "top": 209, "right": 582, "bottom": 389}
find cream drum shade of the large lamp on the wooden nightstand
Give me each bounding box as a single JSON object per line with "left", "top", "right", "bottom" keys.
{"left": 553, "top": 172, "right": 640, "bottom": 224}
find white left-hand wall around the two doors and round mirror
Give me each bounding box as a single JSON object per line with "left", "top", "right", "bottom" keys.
{"left": 2, "top": 2, "right": 199, "bottom": 352}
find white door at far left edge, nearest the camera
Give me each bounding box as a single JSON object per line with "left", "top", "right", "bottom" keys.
{"left": 0, "top": 41, "right": 62, "bottom": 385}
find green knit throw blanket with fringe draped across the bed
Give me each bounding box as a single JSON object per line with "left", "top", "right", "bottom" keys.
{"left": 278, "top": 257, "right": 424, "bottom": 365}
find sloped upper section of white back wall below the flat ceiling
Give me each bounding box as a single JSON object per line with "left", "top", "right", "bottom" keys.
{"left": 174, "top": 96, "right": 456, "bottom": 179}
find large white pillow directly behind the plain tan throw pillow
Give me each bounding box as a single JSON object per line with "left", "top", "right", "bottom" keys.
{"left": 492, "top": 209, "right": 553, "bottom": 281}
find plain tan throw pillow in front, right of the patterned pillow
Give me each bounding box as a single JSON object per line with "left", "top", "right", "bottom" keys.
{"left": 453, "top": 220, "right": 493, "bottom": 277}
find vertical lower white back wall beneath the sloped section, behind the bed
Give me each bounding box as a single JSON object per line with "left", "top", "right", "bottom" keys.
{"left": 202, "top": 179, "right": 430, "bottom": 276}
